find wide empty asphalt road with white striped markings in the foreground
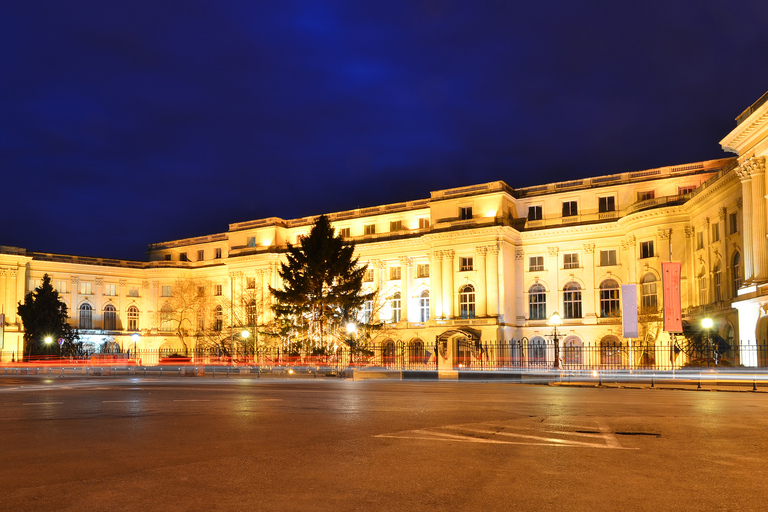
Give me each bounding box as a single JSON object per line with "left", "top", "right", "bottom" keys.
{"left": 0, "top": 377, "right": 768, "bottom": 511}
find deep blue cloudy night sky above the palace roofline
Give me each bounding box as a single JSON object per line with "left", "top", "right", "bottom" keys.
{"left": 0, "top": 0, "right": 768, "bottom": 260}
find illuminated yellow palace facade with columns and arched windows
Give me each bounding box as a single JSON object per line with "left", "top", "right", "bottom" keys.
{"left": 0, "top": 94, "right": 768, "bottom": 365}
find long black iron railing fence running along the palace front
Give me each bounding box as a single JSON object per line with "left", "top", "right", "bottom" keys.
{"left": 0, "top": 338, "right": 768, "bottom": 370}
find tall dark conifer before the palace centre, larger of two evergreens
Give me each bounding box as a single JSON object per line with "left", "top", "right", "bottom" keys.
{"left": 269, "top": 215, "right": 373, "bottom": 352}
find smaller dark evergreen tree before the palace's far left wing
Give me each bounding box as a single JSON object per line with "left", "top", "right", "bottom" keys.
{"left": 18, "top": 274, "right": 79, "bottom": 356}
